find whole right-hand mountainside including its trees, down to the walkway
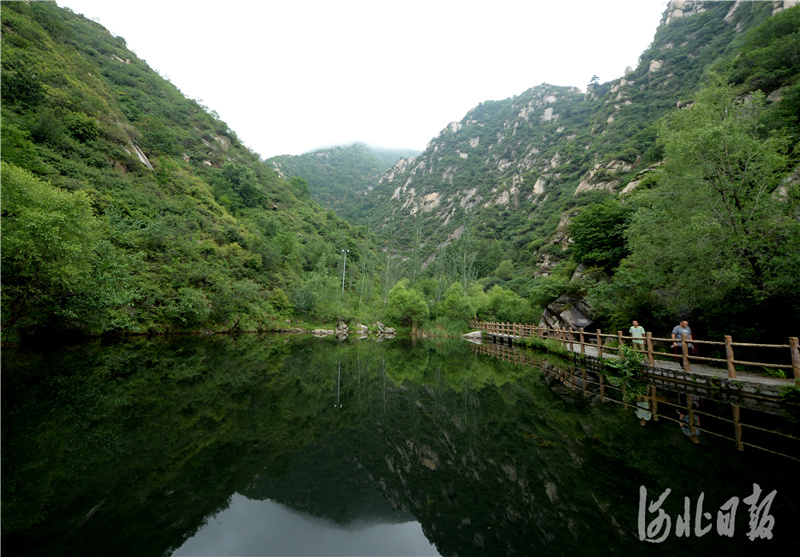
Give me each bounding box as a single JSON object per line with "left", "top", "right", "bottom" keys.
{"left": 340, "top": 2, "right": 800, "bottom": 338}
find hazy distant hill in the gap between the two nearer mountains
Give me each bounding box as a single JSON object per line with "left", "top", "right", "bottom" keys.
{"left": 266, "top": 143, "right": 419, "bottom": 221}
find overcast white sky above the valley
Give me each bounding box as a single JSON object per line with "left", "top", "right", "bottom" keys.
{"left": 57, "top": 0, "right": 667, "bottom": 158}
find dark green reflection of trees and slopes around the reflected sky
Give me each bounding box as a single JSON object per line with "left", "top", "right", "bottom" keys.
{"left": 2, "top": 337, "right": 796, "bottom": 555}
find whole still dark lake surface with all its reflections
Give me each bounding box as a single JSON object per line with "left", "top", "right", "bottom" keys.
{"left": 2, "top": 336, "right": 800, "bottom": 556}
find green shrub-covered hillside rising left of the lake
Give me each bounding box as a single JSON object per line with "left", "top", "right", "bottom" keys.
{"left": 2, "top": 2, "right": 377, "bottom": 341}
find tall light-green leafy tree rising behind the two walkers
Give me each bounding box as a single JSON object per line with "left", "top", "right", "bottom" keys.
{"left": 607, "top": 80, "right": 800, "bottom": 334}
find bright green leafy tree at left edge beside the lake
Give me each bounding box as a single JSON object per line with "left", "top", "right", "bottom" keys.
{"left": 1, "top": 162, "right": 132, "bottom": 331}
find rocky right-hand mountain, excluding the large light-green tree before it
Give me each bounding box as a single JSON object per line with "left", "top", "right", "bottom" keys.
{"left": 272, "top": 1, "right": 800, "bottom": 334}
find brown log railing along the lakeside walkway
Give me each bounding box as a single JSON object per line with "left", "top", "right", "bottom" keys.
{"left": 470, "top": 319, "right": 800, "bottom": 383}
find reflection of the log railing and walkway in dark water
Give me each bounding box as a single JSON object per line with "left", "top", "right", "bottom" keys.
{"left": 471, "top": 343, "right": 800, "bottom": 461}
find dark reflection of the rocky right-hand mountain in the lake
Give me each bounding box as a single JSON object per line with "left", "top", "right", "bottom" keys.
{"left": 241, "top": 338, "right": 790, "bottom": 555}
